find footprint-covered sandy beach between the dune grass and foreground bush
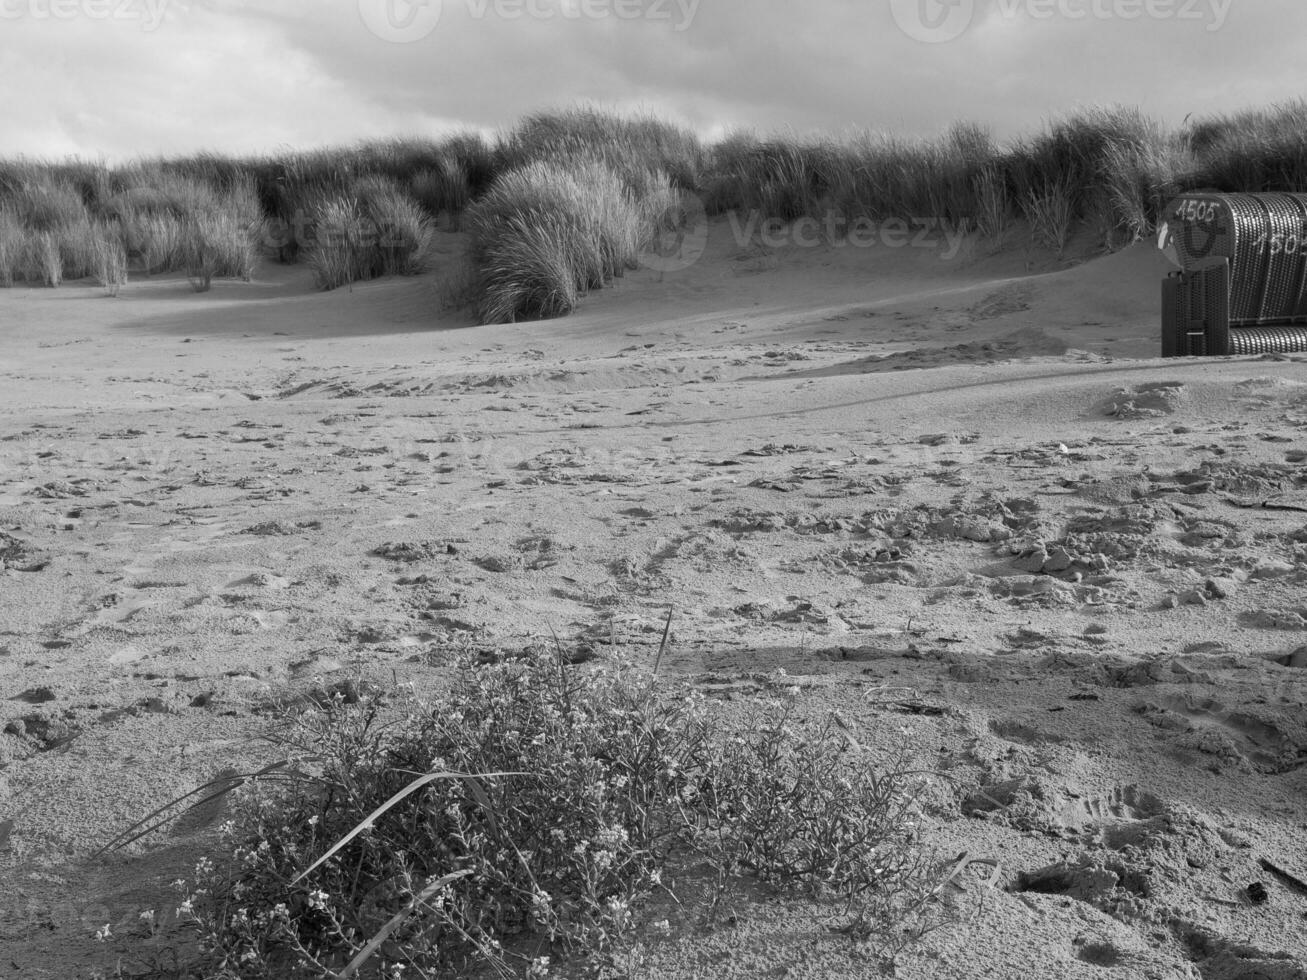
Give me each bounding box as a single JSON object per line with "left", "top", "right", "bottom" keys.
{"left": 0, "top": 226, "right": 1307, "bottom": 980}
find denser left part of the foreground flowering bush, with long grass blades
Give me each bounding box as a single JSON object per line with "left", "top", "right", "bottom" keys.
{"left": 176, "top": 653, "right": 706, "bottom": 980}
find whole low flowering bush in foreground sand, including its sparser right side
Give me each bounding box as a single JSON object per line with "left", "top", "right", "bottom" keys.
{"left": 171, "top": 651, "right": 941, "bottom": 980}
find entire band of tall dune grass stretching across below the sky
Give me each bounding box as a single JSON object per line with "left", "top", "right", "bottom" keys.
{"left": 0, "top": 101, "right": 1307, "bottom": 307}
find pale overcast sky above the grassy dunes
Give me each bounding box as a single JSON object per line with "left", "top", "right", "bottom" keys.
{"left": 0, "top": 0, "right": 1307, "bottom": 159}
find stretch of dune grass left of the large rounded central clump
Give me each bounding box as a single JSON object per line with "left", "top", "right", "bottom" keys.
{"left": 0, "top": 133, "right": 486, "bottom": 290}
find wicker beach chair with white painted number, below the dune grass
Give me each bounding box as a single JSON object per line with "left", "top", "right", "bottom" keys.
{"left": 1158, "top": 193, "right": 1307, "bottom": 357}
